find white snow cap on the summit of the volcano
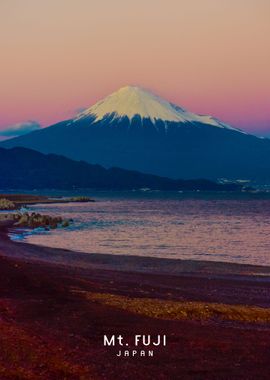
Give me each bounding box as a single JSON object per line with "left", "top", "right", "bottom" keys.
{"left": 74, "top": 86, "right": 243, "bottom": 133}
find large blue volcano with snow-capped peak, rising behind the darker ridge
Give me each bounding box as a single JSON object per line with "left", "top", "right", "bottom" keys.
{"left": 1, "top": 86, "right": 270, "bottom": 183}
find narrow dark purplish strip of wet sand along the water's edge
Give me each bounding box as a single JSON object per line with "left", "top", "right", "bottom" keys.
{"left": 0, "top": 222, "right": 270, "bottom": 281}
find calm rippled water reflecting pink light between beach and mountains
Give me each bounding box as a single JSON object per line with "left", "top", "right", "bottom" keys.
{"left": 12, "top": 193, "right": 270, "bottom": 265}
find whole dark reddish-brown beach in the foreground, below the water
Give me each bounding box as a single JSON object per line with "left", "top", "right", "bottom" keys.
{"left": 0, "top": 224, "right": 270, "bottom": 380}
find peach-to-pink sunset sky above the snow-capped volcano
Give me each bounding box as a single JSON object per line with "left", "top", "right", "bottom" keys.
{"left": 0, "top": 0, "right": 270, "bottom": 135}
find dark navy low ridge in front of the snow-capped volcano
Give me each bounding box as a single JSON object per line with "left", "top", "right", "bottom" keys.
{"left": 0, "top": 148, "right": 241, "bottom": 191}
